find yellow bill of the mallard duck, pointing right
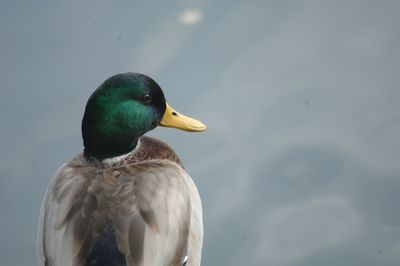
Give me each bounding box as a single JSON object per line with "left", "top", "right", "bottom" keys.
{"left": 160, "top": 103, "right": 207, "bottom": 132}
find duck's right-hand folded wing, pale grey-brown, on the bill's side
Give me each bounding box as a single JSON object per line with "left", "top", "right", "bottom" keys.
{"left": 116, "top": 162, "right": 191, "bottom": 265}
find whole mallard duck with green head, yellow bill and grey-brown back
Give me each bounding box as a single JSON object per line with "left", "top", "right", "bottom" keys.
{"left": 38, "top": 73, "right": 206, "bottom": 266}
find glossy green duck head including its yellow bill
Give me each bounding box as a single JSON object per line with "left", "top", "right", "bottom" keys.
{"left": 82, "top": 73, "right": 207, "bottom": 159}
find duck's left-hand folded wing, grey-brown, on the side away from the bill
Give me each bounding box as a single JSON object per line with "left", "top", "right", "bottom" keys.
{"left": 38, "top": 159, "right": 105, "bottom": 266}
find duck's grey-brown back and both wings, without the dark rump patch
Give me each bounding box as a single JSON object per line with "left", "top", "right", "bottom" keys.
{"left": 38, "top": 138, "right": 203, "bottom": 266}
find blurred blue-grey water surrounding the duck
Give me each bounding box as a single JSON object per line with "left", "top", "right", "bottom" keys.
{"left": 0, "top": 0, "right": 400, "bottom": 266}
